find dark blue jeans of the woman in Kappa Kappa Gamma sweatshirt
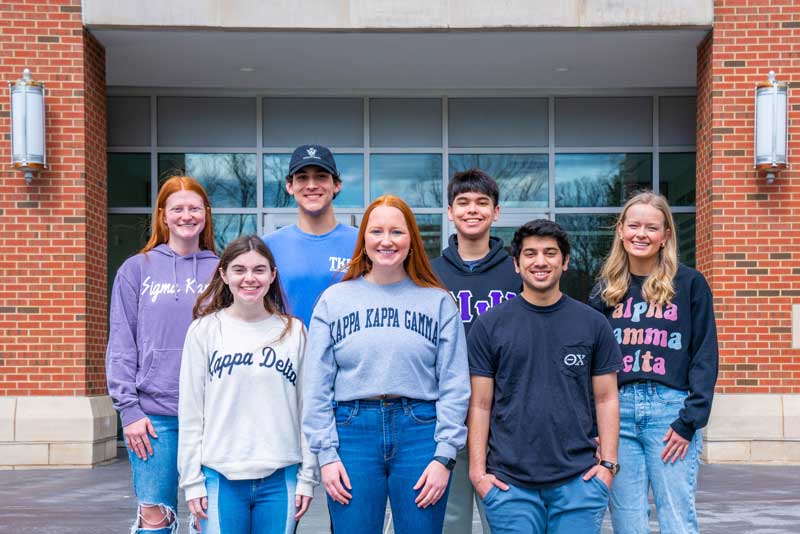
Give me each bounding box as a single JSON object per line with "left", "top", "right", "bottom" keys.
{"left": 328, "top": 398, "right": 449, "bottom": 534}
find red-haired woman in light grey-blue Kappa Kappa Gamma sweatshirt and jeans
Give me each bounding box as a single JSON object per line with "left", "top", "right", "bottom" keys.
{"left": 303, "top": 195, "right": 470, "bottom": 534}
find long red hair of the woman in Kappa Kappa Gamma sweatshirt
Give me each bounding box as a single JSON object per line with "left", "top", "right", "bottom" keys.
{"left": 342, "top": 195, "right": 447, "bottom": 291}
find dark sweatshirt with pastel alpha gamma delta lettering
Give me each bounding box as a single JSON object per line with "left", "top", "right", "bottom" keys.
{"left": 589, "top": 264, "right": 719, "bottom": 439}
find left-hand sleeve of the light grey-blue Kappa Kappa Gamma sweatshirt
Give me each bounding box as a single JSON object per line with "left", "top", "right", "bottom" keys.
{"left": 303, "top": 302, "right": 339, "bottom": 467}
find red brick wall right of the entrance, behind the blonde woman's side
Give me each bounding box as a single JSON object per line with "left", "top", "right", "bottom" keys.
{"left": 697, "top": 0, "right": 800, "bottom": 393}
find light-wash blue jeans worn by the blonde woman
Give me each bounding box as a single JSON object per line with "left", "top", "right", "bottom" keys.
{"left": 610, "top": 382, "right": 703, "bottom": 534}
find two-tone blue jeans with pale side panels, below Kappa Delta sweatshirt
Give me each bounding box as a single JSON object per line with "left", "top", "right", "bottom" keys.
{"left": 198, "top": 464, "right": 297, "bottom": 534}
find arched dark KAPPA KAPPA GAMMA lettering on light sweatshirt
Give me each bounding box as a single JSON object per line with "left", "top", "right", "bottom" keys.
{"left": 328, "top": 306, "right": 439, "bottom": 346}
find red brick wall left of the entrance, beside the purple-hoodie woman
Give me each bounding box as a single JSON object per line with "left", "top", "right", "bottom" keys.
{"left": 0, "top": 0, "right": 106, "bottom": 396}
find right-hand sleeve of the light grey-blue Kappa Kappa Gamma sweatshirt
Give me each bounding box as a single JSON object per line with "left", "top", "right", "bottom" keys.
{"left": 433, "top": 300, "right": 470, "bottom": 458}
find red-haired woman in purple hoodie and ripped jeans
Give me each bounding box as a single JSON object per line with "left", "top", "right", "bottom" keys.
{"left": 106, "top": 176, "right": 218, "bottom": 534}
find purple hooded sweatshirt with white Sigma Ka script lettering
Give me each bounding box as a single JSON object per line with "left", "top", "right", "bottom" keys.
{"left": 106, "top": 244, "right": 219, "bottom": 426}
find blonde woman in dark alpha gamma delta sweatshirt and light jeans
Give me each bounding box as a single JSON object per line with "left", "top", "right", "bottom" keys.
{"left": 590, "top": 192, "right": 718, "bottom": 534}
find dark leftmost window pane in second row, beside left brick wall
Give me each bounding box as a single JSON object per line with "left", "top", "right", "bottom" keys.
{"left": 108, "top": 153, "right": 152, "bottom": 208}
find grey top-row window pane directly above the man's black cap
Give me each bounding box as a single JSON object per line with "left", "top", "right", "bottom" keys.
{"left": 262, "top": 98, "right": 364, "bottom": 149}
